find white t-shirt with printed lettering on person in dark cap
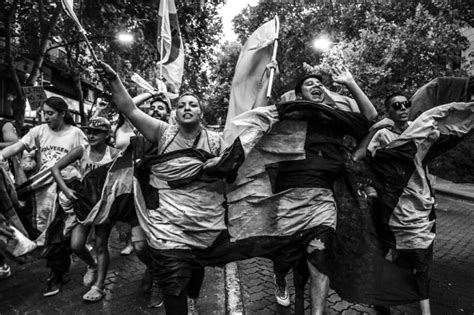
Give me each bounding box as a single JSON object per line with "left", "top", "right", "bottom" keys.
{"left": 20, "top": 124, "right": 87, "bottom": 178}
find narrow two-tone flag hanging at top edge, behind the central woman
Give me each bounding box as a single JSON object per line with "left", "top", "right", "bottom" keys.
{"left": 157, "top": 0, "right": 184, "bottom": 93}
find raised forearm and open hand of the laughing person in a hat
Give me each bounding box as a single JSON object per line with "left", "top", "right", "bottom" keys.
{"left": 332, "top": 68, "right": 378, "bottom": 121}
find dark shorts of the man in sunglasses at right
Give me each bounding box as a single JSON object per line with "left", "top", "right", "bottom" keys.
{"left": 395, "top": 244, "right": 433, "bottom": 300}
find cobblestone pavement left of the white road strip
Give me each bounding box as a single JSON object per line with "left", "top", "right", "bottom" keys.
{"left": 0, "top": 229, "right": 225, "bottom": 315}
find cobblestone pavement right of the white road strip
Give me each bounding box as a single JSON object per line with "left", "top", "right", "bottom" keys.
{"left": 238, "top": 196, "right": 474, "bottom": 315}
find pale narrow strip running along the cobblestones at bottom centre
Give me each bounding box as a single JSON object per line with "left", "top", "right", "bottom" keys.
{"left": 224, "top": 262, "right": 244, "bottom": 315}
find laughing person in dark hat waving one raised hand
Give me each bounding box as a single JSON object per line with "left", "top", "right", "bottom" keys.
{"left": 274, "top": 68, "right": 377, "bottom": 314}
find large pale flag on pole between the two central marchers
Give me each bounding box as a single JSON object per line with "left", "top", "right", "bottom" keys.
{"left": 226, "top": 17, "right": 278, "bottom": 132}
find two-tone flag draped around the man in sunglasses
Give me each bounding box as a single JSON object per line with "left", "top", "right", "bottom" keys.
{"left": 371, "top": 103, "right": 474, "bottom": 253}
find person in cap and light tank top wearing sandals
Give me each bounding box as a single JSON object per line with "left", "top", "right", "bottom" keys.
{"left": 51, "top": 117, "right": 120, "bottom": 302}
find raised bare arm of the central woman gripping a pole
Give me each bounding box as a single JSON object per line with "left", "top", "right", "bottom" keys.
{"left": 98, "top": 62, "right": 167, "bottom": 143}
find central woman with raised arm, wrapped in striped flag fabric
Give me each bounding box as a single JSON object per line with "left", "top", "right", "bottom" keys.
{"left": 101, "top": 63, "right": 226, "bottom": 314}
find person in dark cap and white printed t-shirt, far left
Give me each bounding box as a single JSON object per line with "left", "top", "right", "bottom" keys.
{"left": 0, "top": 96, "right": 87, "bottom": 297}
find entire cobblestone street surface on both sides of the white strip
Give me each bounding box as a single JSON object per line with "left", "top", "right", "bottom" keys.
{"left": 0, "top": 196, "right": 474, "bottom": 315}
